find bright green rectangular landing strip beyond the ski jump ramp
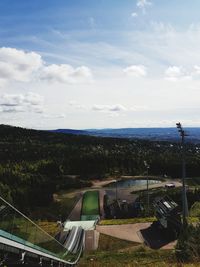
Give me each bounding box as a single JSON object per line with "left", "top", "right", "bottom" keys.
{"left": 81, "top": 191, "right": 99, "bottom": 216}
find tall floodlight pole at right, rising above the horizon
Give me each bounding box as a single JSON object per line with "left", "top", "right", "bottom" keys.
{"left": 176, "top": 122, "right": 188, "bottom": 226}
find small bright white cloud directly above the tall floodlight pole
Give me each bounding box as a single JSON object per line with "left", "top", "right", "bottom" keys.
{"left": 165, "top": 66, "right": 192, "bottom": 81}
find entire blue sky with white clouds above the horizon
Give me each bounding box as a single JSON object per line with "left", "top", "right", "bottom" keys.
{"left": 0, "top": 0, "right": 200, "bottom": 129}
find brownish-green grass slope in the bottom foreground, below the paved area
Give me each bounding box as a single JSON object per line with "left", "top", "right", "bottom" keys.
{"left": 78, "top": 234, "right": 180, "bottom": 267}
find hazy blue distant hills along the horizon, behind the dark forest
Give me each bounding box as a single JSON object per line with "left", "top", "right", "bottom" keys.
{"left": 50, "top": 127, "right": 200, "bottom": 143}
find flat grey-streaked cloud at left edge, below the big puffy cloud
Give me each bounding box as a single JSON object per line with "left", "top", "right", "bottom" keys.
{"left": 0, "top": 93, "right": 43, "bottom": 113}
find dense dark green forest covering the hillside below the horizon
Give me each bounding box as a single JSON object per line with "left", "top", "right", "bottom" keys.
{"left": 0, "top": 125, "right": 200, "bottom": 215}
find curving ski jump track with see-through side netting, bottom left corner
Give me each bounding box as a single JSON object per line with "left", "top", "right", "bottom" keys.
{"left": 0, "top": 197, "right": 84, "bottom": 265}
